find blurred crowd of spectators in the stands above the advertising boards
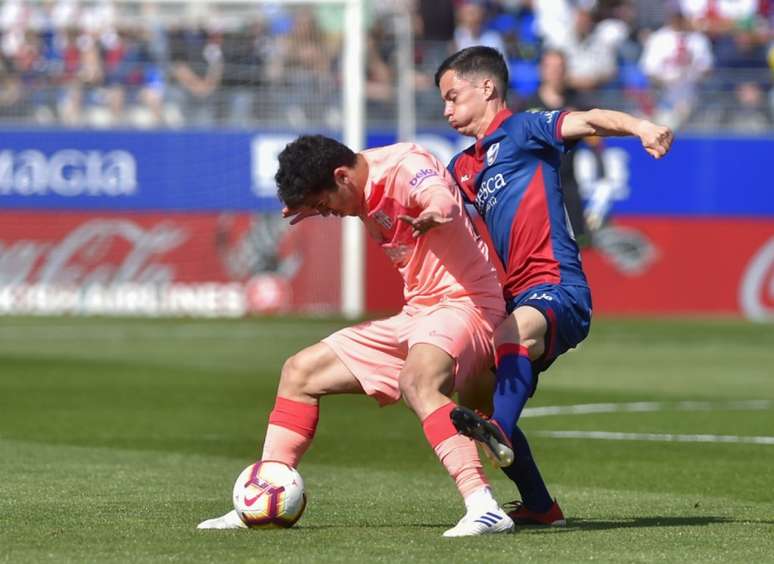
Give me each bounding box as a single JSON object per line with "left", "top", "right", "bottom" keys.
{"left": 0, "top": 0, "right": 774, "bottom": 133}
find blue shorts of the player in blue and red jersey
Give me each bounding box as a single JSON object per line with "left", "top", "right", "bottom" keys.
{"left": 507, "top": 284, "right": 591, "bottom": 378}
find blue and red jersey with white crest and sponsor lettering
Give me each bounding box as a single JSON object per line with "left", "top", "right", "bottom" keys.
{"left": 448, "top": 110, "right": 587, "bottom": 298}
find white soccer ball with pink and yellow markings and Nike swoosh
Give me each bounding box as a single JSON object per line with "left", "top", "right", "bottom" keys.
{"left": 234, "top": 460, "right": 306, "bottom": 529}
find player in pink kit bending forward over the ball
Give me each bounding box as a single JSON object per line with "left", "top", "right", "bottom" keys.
{"left": 199, "top": 135, "right": 513, "bottom": 537}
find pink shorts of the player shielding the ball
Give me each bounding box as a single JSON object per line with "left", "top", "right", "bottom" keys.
{"left": 322, "top": 301, "right": 505, "bottom": 405}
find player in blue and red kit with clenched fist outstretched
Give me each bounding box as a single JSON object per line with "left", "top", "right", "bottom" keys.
{"left": 435, "top": 46, "right": 673, "bottom": 525}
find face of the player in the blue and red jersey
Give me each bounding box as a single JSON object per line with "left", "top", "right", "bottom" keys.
{"left": 438, "top": 70, "right": 487, "bottom": 136}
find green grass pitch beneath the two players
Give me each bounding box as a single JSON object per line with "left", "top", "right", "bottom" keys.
{"left": 0, "top": 318, "right": 774, "bottom": 563}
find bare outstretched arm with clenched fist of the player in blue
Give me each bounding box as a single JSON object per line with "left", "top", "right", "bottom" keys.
{"left": 561, "top": 109, "right": 674, "bottom": 159}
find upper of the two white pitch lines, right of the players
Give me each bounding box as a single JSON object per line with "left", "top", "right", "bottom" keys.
{"left": 521, "top": 400, "right": 774, "bottom": 417}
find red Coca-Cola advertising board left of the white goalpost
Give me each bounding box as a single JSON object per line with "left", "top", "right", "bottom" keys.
{"left": 0, "top": 212, "right": 340, "bottom": 316}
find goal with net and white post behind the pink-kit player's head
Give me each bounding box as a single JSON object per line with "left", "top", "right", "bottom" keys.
{"left": 0, "top": 0, "right": 365, "bottom": 316}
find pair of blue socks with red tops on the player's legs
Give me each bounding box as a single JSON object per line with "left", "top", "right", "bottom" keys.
{"left": 492, "top": 344, "right": 553, "bottom": 512}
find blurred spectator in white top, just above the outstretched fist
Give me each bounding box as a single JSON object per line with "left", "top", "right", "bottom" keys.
{"left": 640, "top": 7, "right": 713, "bottom": 128}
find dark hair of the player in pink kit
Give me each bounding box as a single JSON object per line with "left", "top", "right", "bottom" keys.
{"left": 274, "top": 135, "right": 357, "bottom": 209}
